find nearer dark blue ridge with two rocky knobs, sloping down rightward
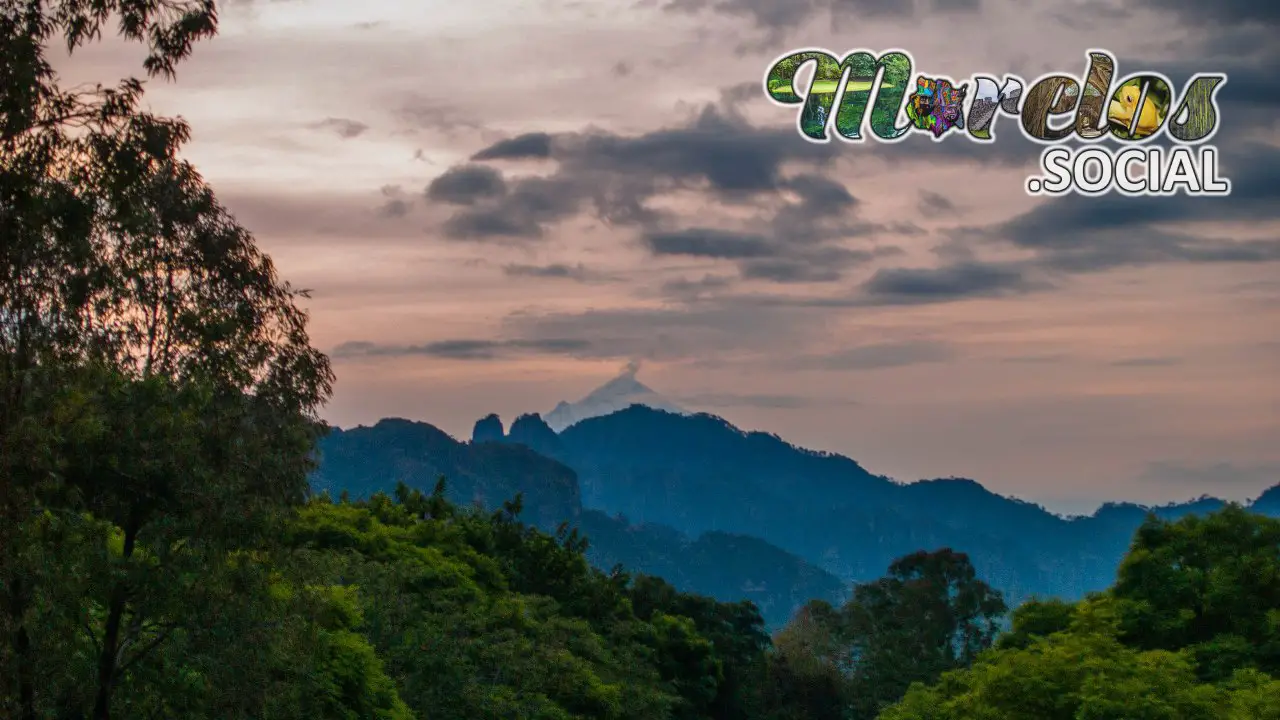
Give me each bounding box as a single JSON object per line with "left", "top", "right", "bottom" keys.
{"left": 311, "top": 414, "right": 845, "bottom": 626}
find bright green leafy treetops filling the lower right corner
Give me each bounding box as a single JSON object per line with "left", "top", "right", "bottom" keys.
{"left": 881, "top": 506, "right": 1280, "bottom": 720}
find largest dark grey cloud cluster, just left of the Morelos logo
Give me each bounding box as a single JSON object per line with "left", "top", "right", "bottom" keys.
{"left": 448, "top": 106, "right": 874, "bottom": 262}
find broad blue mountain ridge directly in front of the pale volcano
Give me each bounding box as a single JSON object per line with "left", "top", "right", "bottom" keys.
{"left": 507, "top": 405, "right": 1275, "bottom": 601}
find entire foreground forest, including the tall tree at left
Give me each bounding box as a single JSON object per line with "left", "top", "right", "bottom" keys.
{"left": 0, "top": 0, "right": 1280, "bottom": 720}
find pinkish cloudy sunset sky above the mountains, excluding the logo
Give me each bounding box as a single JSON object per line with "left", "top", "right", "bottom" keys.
{"left": 58, "top": 0, "right": 1280, "bottom": 511}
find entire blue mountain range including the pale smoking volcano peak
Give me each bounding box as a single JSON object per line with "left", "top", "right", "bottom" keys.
{"left": 314, "top": 366, "right": 1280, "bottom": 626}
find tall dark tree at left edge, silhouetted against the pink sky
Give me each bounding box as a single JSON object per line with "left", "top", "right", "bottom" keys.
{"left": 0, "top": 0, "right": 333, "bottom": 719}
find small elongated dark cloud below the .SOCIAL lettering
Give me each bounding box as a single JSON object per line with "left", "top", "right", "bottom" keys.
{"left": 860, "top": 263, "right": 1043, "bottom": 305}
